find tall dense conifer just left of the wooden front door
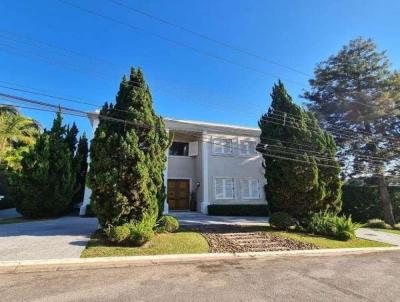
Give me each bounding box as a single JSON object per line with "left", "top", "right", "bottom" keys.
{"left": 89, "top": 68, "right": 169, "bottom": 227}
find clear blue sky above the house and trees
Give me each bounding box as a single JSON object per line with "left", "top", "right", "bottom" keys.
{"left": 0, "top": 0, "right": 400, "bottom": 138}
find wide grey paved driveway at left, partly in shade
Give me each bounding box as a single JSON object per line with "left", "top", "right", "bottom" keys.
{"left": 0, "top": 217, "right": 98, "bottom": 261}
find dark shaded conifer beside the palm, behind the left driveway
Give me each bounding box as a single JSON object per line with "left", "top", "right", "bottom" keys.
{"left": 12, "top": 113, "right": 75, "bottom": 218}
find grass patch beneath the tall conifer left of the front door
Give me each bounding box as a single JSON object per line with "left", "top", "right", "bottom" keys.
{"left": 81, "top": 231, "right": 208, "bottom": 258}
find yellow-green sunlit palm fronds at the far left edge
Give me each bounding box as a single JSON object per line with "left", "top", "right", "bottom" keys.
{"left": 0, "top": 105, "right": 40, "bottom": 169}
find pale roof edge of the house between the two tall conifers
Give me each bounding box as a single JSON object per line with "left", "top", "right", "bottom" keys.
{"left": 164, "top": 118, "right": 261, "bottom": 136}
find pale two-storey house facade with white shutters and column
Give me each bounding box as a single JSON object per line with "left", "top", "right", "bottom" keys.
{"left": 80, "top": 116, "right": 267, "bottom": 215}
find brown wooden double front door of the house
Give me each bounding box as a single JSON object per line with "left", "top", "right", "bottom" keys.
{"left": 168, "top": 179, "right": 190, "bottom": 210}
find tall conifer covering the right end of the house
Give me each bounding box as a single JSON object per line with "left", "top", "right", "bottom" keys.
{"left": 258, "top": 81, "right": 341, "bottom": 218}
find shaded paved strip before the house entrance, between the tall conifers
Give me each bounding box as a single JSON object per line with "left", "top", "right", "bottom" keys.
{"left": 169, "top": 212, "right": 268, "bottom": 226}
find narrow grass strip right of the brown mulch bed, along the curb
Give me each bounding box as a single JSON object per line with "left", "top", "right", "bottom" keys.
{"left": 273, "top": 231, "right": 391, "bottom": 249}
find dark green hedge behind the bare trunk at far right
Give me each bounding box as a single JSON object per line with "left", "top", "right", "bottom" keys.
{"left": 342, "top": 185, "right": 400, "bottom": 223}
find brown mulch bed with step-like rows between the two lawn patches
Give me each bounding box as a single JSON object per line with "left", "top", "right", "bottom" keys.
{"left": 186, "top": 226, "right": 318, "bottom": 253}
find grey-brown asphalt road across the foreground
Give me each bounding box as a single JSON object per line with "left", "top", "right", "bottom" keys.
{"left": 0, "top": 252, "right": 400, "bottom": 302}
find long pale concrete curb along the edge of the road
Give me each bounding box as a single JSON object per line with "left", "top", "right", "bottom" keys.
{"left": 0, "top": 247, "right": 400, "bottom": 273}
